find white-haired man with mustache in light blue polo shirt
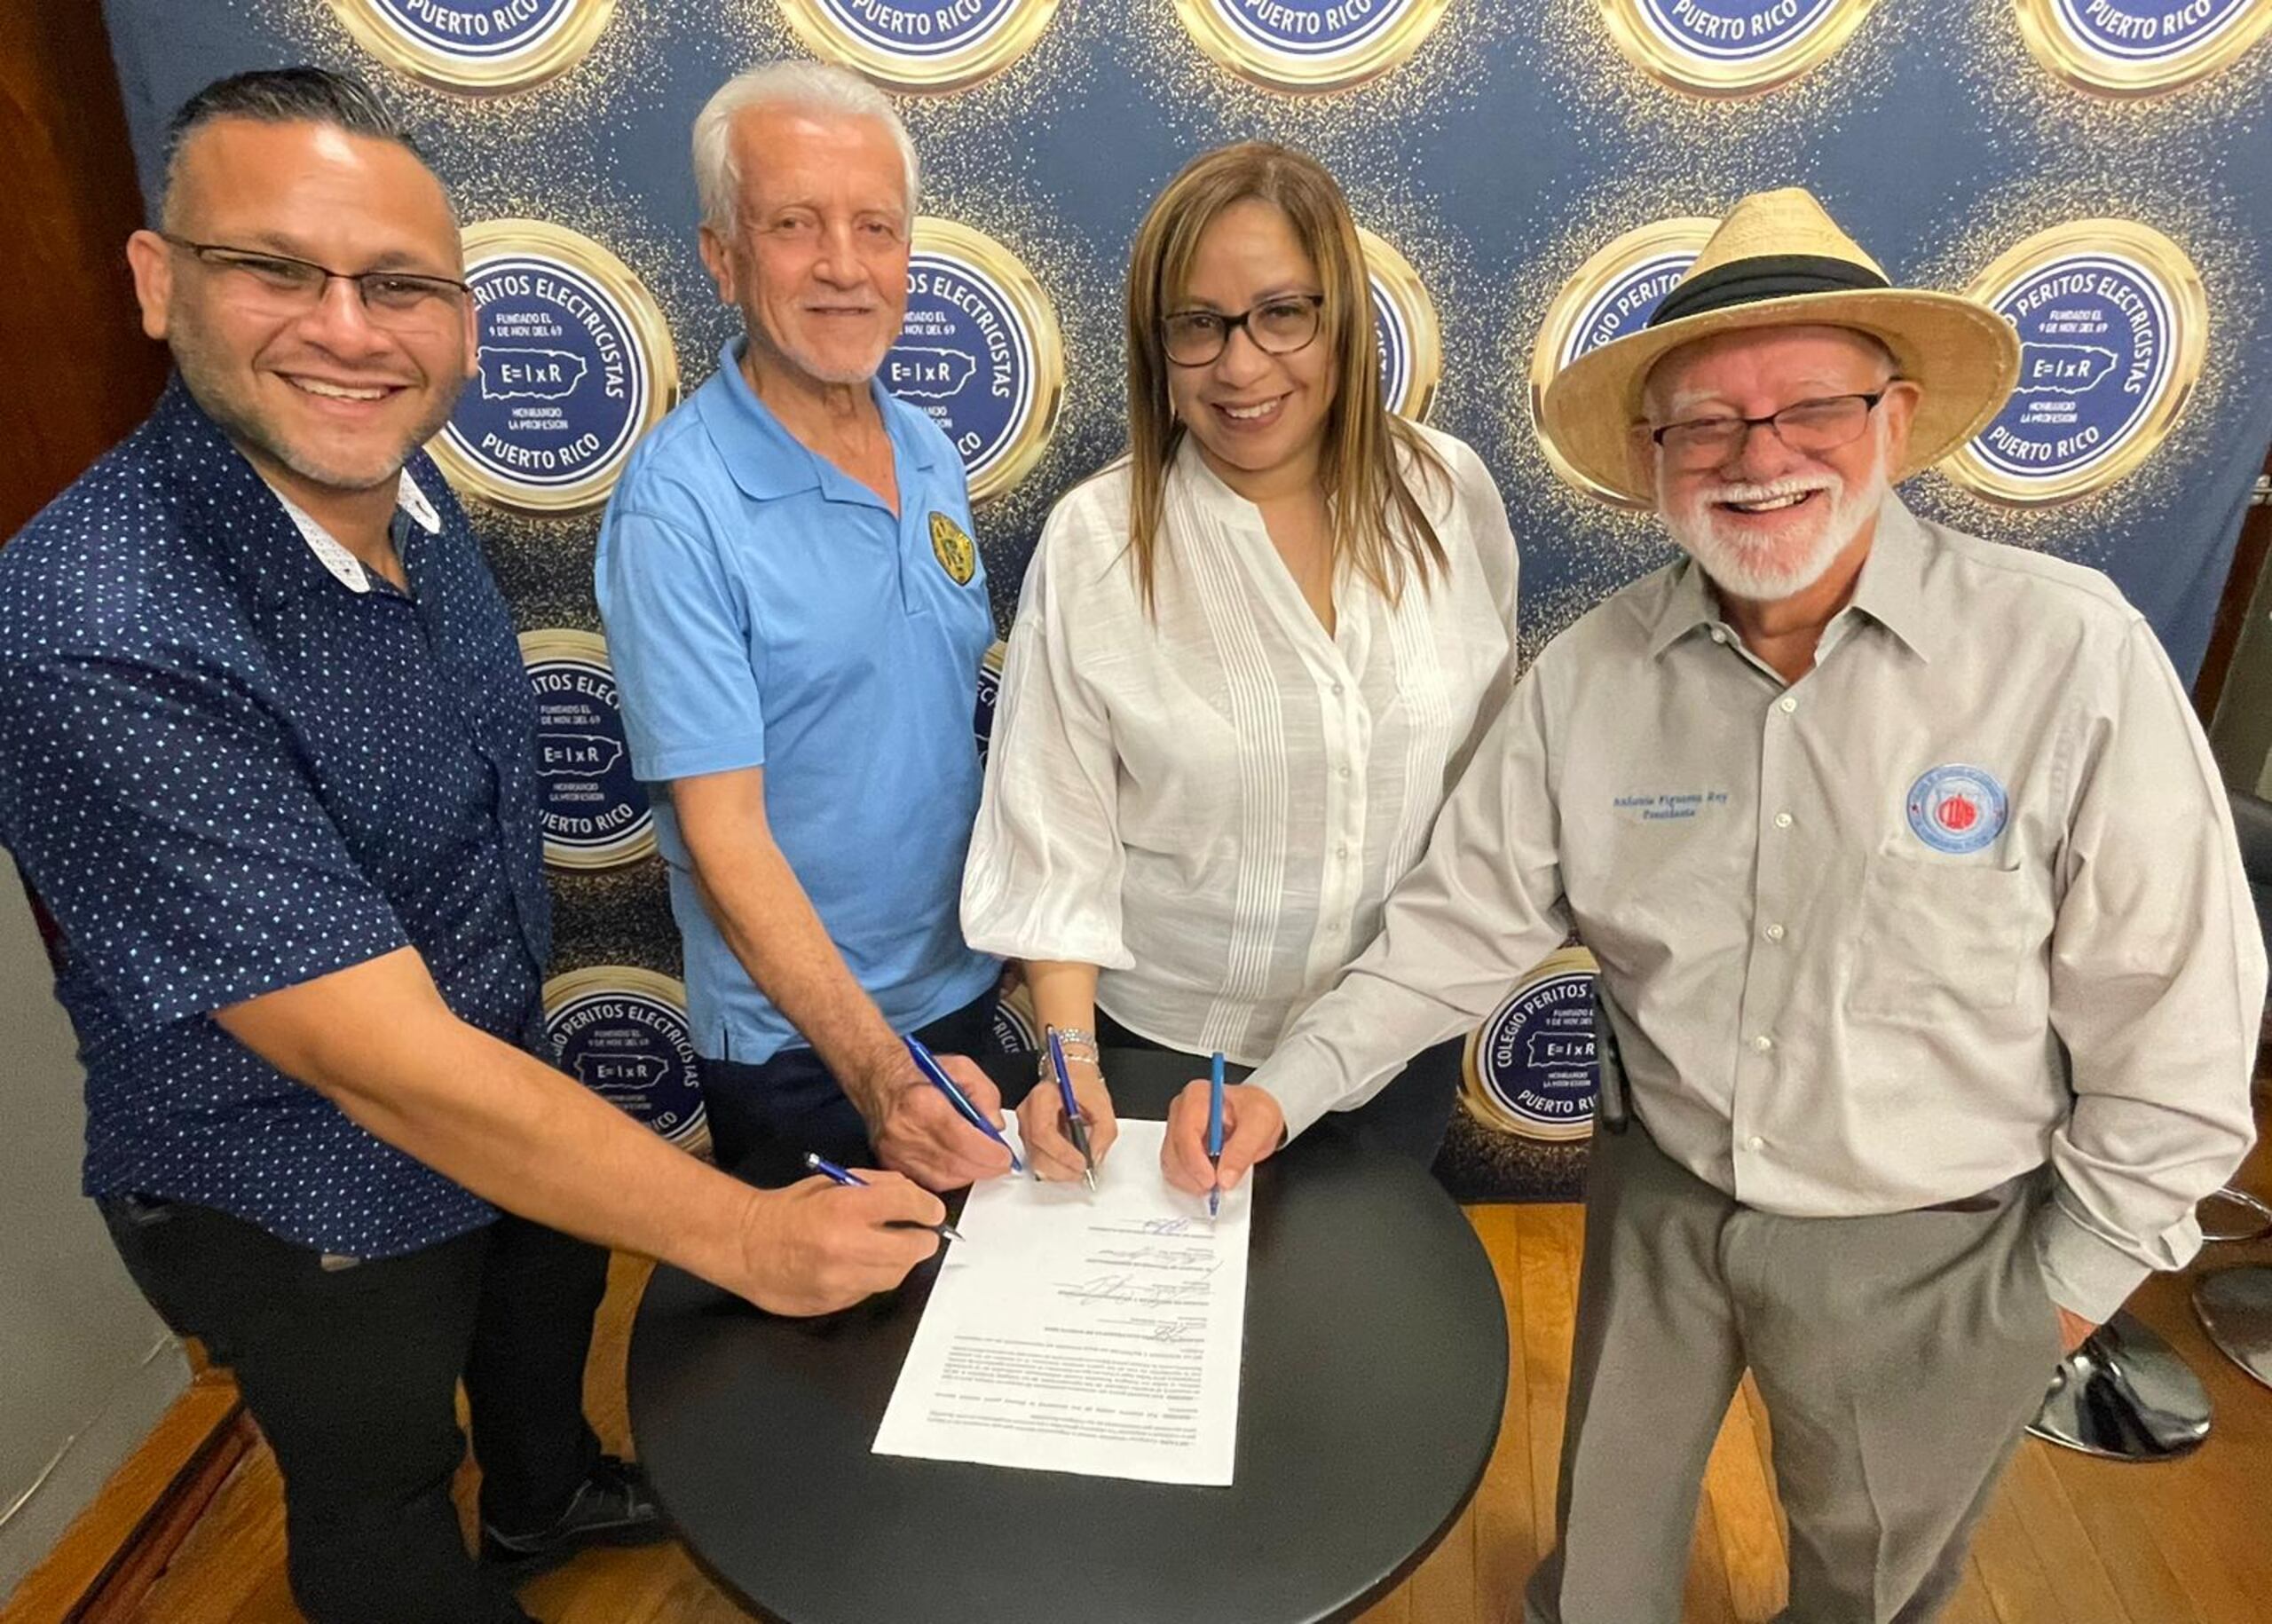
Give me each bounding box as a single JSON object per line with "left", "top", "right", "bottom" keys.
{"left": 596, "top": 61, "right": 1009, "bottom": 1190}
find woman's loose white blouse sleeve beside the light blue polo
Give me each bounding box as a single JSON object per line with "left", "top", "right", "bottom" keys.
{"left": 961, "top": 533, "right": 1136, "bottom": 970}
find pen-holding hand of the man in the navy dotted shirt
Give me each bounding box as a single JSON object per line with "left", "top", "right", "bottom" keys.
{"left": 721, "top": 1172, "right": 948, "bottom": 1315}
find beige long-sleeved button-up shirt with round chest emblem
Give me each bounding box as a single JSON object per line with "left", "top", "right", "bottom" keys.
{"left": 1252, "top": 498, "right": 2265, "bottom": 1320}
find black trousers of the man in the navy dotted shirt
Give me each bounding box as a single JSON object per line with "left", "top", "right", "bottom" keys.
{"left": 100, "top": 1197, "right": 607, "bottom": 1624}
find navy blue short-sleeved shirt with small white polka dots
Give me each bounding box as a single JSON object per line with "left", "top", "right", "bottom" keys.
{"left": 0, "top": 379, "right": 550, "bottom": 1258}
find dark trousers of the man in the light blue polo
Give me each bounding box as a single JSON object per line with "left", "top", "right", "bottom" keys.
{"left": 702, "top": 988, "right": 999, "bottom": 1188}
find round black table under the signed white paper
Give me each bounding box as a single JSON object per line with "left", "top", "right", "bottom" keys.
{"left": 629, "top": 1052, "right": 1506, "bottom": 1624}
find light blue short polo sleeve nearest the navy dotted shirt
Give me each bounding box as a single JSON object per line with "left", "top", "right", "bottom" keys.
{"left": 593, "top": 507, "right": 766, "bottom": 784}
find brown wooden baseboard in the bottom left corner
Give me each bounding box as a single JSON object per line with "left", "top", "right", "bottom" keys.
{"left": 0, "top": 1372, "right": 256, "bottom": 1624}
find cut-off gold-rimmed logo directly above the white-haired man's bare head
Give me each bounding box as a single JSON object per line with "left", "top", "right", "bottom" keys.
{"left": 782, "top": 0, "right": 1056, "bottom": 95}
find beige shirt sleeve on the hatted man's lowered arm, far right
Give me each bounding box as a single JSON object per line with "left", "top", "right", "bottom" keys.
{"left": 2040, "top": 622, "right": 2265, "bottom": 1322}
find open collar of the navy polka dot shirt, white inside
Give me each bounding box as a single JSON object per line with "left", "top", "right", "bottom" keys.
{"left": 157, "top": 374, "right": 441, "bottom": 604}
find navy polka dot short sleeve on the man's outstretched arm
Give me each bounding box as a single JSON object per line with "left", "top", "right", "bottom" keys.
{"left": 0, "top": 652, "right": 409, "bottom": 1027}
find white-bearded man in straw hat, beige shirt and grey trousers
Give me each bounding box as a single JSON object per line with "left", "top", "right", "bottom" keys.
{"left": 1165, "top": 191, "right": 2265, "bottom": 1624}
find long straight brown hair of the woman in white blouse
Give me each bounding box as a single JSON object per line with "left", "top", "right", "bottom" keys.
{"left": 1127, "top": 141, "right": 1449, "bottom": 606}
